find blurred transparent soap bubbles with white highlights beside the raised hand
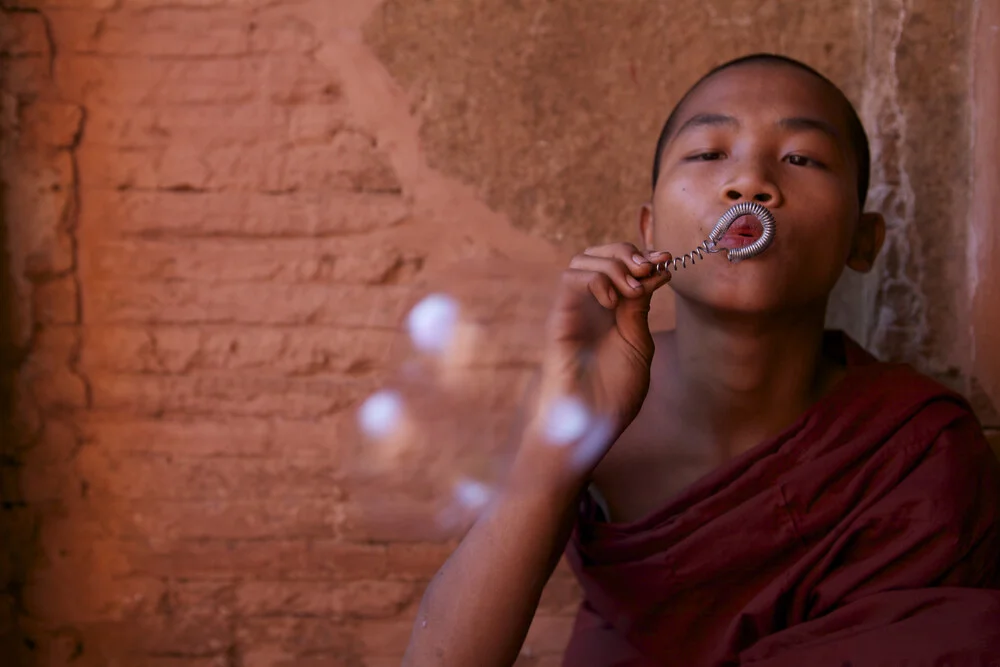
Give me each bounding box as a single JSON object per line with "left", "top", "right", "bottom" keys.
{"left": 349, "top": 262, "right": 560, "bottom": 532}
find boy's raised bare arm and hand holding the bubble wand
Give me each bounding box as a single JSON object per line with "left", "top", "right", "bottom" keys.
{"left": 403, "top": 243, "right": 670, "bottom": 667}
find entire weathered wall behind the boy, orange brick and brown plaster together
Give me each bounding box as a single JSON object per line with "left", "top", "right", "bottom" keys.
{"left": 0, "top": 0, "right": 998, "bottom": 667}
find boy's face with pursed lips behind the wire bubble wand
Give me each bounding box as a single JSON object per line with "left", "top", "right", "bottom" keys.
{"left": 641, "top": 63, "right": 860, "bottom": 313}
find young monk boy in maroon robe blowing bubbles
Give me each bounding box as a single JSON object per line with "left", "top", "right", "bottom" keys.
{"left": 405, "top": 55, "right": 1000, "bottom": 667}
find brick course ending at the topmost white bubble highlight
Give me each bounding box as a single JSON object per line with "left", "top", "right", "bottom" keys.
{"left": 87, "top": 280, "right": 413, "bottom": 329}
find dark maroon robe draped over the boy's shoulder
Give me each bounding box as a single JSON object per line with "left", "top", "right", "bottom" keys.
{"left": 564, "top": 341, "right": 1000, "bottom": 667}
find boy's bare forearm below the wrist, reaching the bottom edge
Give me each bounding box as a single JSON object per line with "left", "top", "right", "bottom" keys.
{"left": 403, "top": 470, "right": 575, "bottom": 667}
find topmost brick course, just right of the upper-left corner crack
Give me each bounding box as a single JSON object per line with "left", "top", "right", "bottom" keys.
{"left": 46, "top": 7, "right": 251, "bottom": 56}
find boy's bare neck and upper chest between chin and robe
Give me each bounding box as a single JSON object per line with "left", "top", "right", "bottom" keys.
{"left": 673, "top": 297, "right": 832, "bottom": 456}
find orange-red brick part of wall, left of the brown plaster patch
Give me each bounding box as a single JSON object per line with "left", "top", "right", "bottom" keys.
{"left": 0, "top": 0, "right": 996, "bottom": 667}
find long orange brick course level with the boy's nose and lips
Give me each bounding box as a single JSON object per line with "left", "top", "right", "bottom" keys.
{"left": 80, "top": 191, "right": 408, "bottom": 238}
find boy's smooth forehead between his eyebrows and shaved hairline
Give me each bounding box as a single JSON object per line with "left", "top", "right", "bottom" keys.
{"left": 675, "top": 63, "right": 849, "bottom": 138}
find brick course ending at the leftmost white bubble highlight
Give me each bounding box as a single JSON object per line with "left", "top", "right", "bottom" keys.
{"left": 86, "top": 372, "right": 376, "bottom": 418}
